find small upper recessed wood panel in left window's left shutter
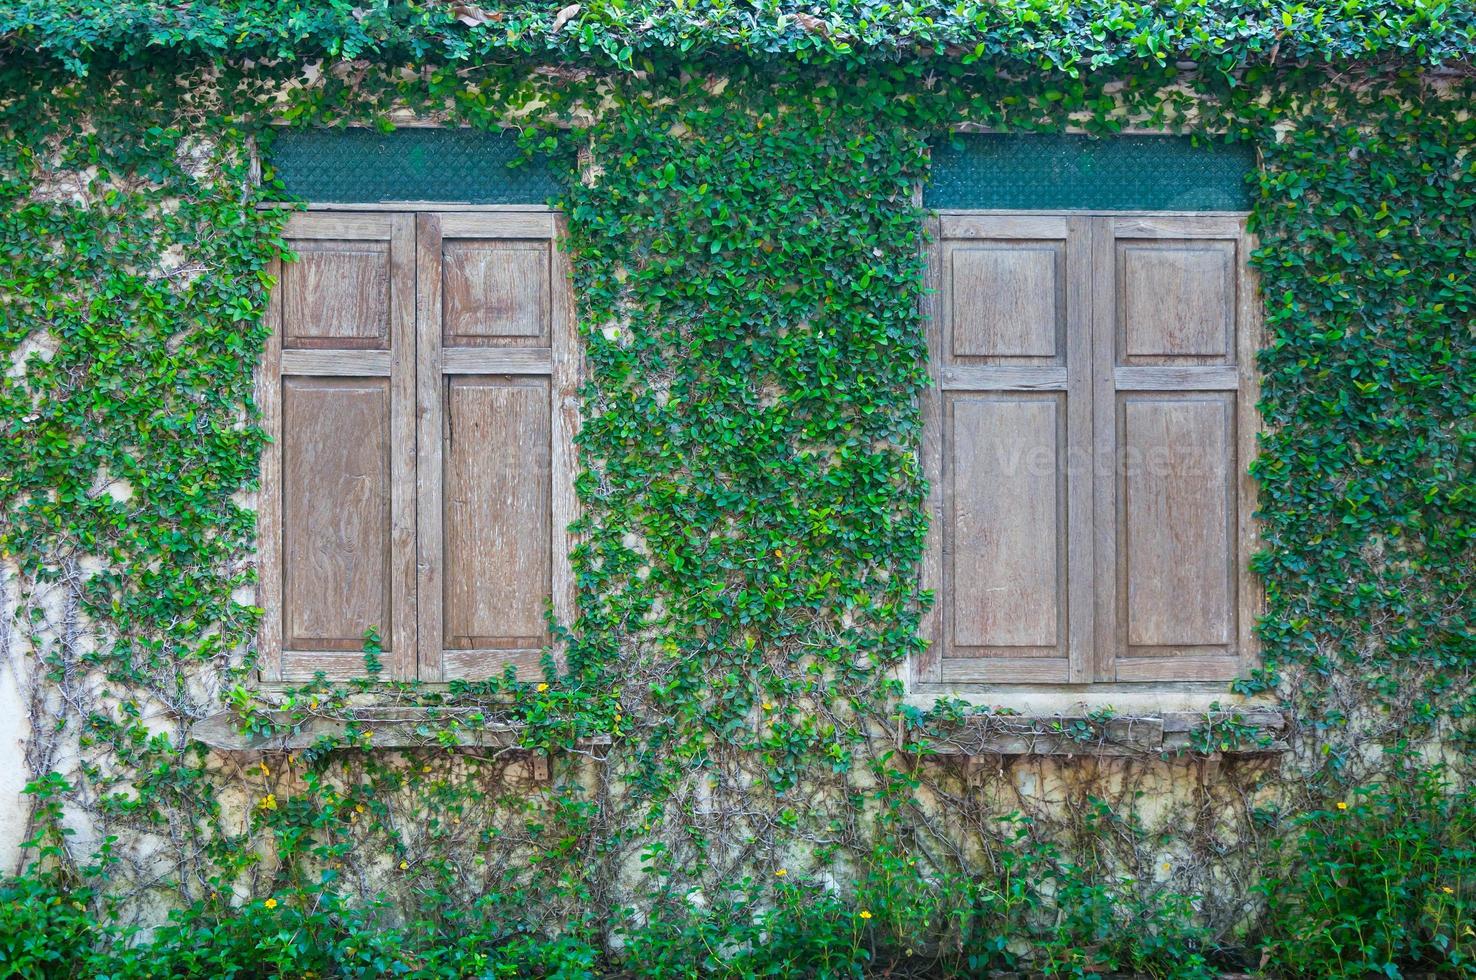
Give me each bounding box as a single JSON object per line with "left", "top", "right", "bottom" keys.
{"left": 282, "top": 241, "right": 390, "bottom": 350}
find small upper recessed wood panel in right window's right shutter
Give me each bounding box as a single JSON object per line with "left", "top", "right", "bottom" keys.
{"left": 1116, "top": 239, "right": 1235, "bottom": 365}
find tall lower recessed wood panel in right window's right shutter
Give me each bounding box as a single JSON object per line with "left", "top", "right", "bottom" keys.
{"left": 1119, "top": 396, "right": 1235, "bottom": 655}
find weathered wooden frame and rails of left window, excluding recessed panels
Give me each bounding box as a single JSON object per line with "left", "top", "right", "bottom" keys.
{"left": 255, "top": 201, "right": 583, "bottom": 689}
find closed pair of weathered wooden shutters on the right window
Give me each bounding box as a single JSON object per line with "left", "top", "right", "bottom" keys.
{"left": 918, "top": 214, "right": 1255, "bottom": 683}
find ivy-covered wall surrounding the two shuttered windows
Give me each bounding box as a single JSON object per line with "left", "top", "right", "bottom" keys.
{"left": 0, "top": 3, "right": 1476, "bottom": 976}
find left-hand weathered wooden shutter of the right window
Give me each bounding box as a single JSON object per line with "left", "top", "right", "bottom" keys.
{"left": 923, "top": 217, "right": 1091, "bottom": 683}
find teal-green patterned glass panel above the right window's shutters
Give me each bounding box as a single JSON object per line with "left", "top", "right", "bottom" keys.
{"left": 923, "top": 133, "right": 1256, "bottom": 211}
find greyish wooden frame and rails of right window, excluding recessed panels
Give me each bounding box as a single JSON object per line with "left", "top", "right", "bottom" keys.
{"left": 905, "top": 210, "right": 1263, "bottom": 704}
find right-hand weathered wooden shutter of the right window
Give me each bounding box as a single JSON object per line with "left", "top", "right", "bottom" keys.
{"left": 1094, "top": 215, "right": 1255, "bottom": 680}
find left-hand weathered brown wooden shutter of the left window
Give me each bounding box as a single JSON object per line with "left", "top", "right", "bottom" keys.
{"left": 257, "top": 214, "right": 416, "bottom": 682}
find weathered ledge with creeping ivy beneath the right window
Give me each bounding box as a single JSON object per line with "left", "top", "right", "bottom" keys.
{"left": 903, "top": 708, "right": 1287, "bottom": 757}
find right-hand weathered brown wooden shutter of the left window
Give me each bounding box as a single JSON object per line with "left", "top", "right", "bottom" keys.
{"left": 418, "top": 213, "right": 577, "bottom": 680}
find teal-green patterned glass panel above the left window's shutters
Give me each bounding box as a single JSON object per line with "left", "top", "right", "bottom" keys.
{"left": 269, "top": 128, "right": 559, "bottom": 204}
